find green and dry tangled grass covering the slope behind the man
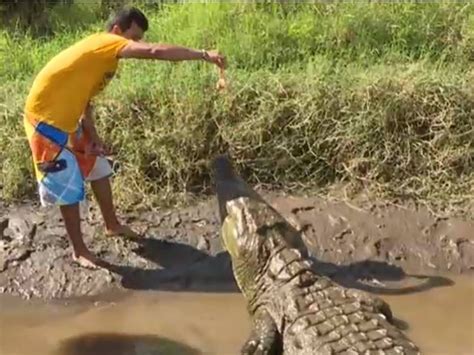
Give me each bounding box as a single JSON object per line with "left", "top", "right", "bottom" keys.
{"left": 0, "top": 2, "right": 474, "bottom": 211}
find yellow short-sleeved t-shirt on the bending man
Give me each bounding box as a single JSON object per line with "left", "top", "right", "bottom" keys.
{"left": 25, "top": 33, "right": 129, "bottom": 133}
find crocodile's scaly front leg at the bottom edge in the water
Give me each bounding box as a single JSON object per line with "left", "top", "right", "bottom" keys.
{"left": 241, "top": 309, "right": 281, "bottom": 355}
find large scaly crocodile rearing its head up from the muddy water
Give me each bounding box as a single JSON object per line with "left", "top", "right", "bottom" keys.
{"left": 212, "top": 155, "right": 420, "bottom": 355}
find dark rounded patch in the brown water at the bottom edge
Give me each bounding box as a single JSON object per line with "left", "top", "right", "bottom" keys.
{"left": 54, "top": 333, "right": 201, "bottom": 355}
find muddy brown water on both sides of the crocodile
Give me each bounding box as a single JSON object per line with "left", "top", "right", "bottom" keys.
{"left": 0, "top": 276, "right": 474, "bottom": 355}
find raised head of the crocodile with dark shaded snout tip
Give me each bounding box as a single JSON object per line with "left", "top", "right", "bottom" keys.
{"left": 213, "top": 156, "right": 306, "bottom": 299}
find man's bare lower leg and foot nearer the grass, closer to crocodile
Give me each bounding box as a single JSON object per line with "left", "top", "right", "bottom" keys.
{"left": 91, "top": 177, "right": 137, "bottom": 237}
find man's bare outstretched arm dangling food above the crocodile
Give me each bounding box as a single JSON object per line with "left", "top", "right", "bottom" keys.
{"left": 118, "top": 41, "right": 225, "bottom": 68}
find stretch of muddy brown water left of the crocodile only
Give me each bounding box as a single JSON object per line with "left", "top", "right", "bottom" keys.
{"left": 0, "top": 292, "right": 249, "bottom": 355}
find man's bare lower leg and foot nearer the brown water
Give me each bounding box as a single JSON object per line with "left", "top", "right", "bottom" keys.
{"left": 60, "top": 203, "right": 101, "bottom": 266}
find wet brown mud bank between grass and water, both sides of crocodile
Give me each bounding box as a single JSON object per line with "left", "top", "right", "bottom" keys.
{"left": 0, "top": 194, "right": 474, "bottom": 299}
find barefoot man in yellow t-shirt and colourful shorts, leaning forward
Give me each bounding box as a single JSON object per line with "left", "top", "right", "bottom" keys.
{"left": 24, "top": 7, "right": 225, "bottom": 267}
